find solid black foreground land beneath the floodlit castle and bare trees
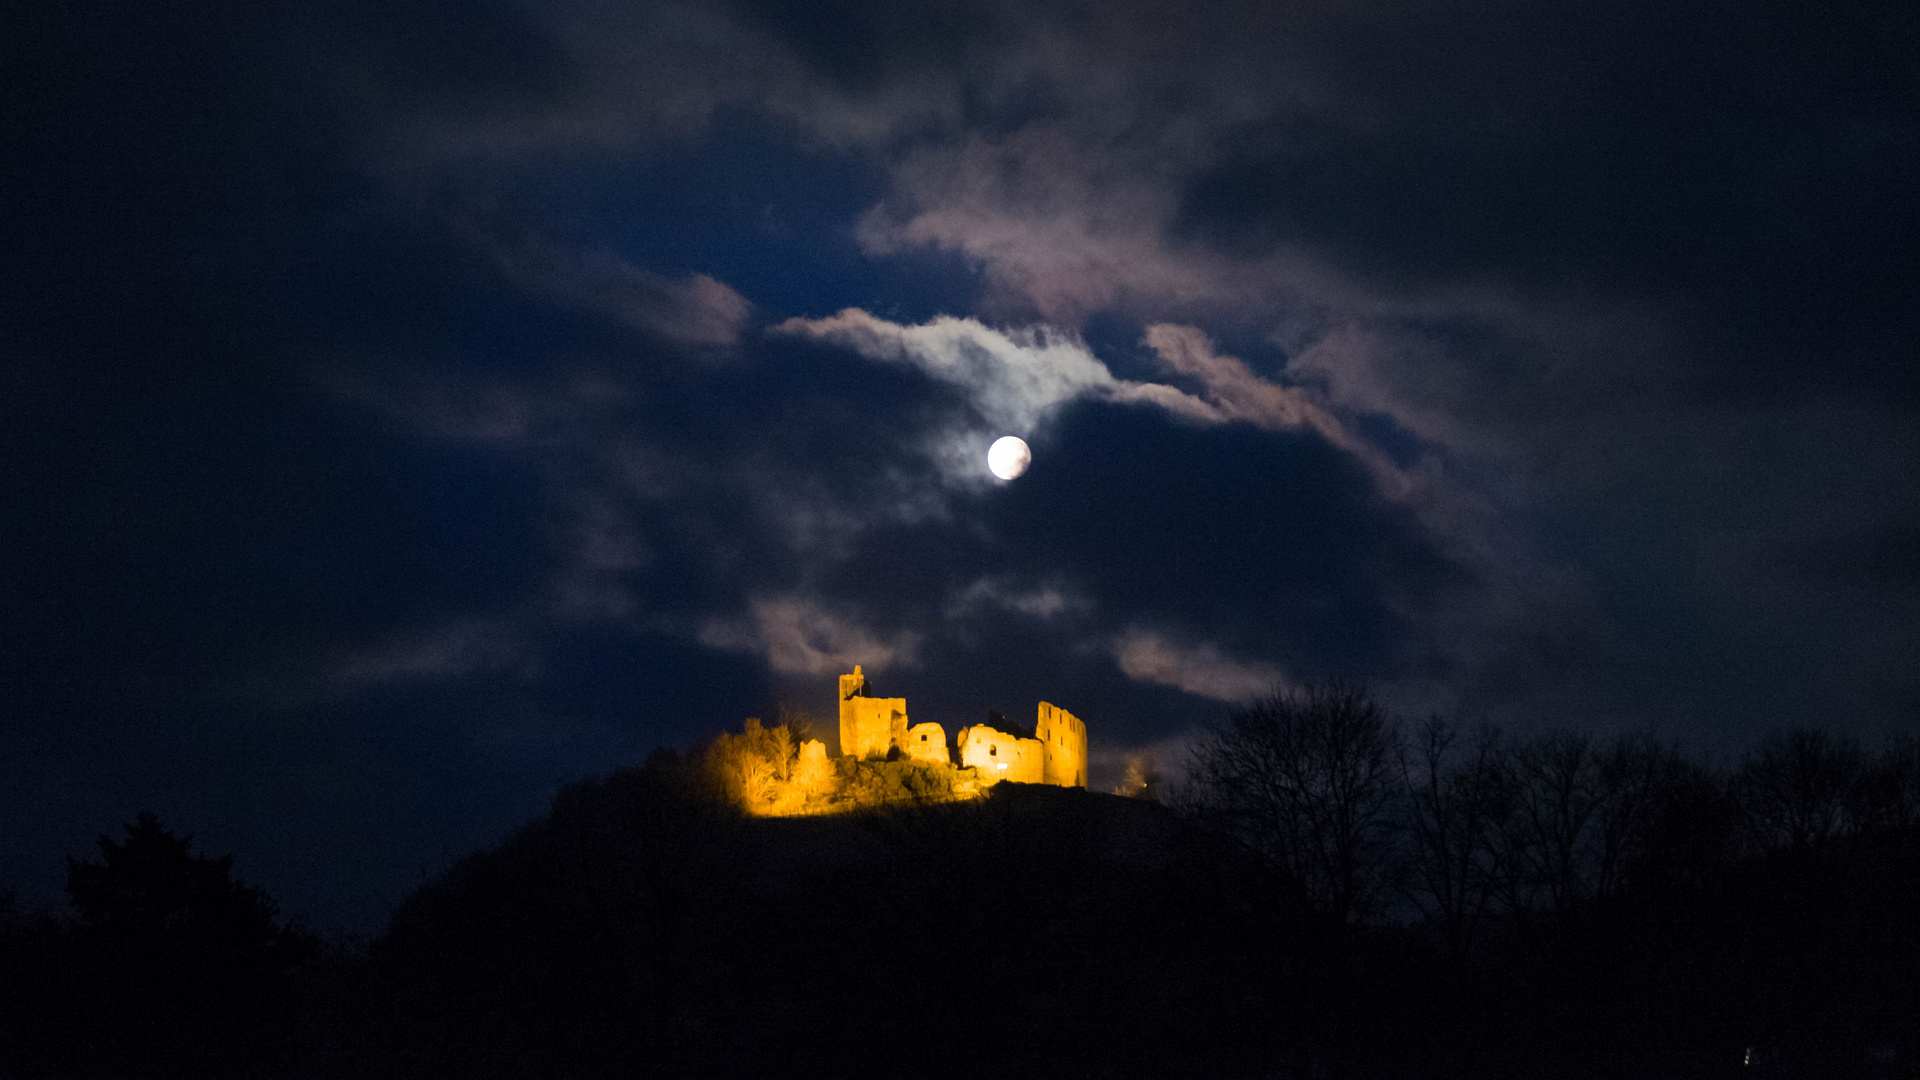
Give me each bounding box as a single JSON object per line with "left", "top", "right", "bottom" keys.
{"left": 0, "top": 753, "right": 1920, "bottom": 1078}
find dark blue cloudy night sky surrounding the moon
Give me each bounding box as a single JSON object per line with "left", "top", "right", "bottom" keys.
{"left": 0, "top": 0, "right": 1920, "bottom": 932}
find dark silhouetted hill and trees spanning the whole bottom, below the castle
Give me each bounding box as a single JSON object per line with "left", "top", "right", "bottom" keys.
{"left": 0, "top": 684, "right": 1920, "bottom": 1078}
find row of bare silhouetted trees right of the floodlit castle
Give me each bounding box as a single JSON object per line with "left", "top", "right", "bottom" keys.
{"left": 1167, "top": 682, "right": 1920, "bottom": 945}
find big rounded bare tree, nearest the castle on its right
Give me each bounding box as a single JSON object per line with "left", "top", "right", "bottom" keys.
{"left": 1187, "top": 682, "right": 1398, "bottom": 922}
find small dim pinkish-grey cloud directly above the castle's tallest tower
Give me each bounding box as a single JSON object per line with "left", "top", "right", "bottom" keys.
{"left": 699, "top": 596, "right": 922, "bottom": 675}
